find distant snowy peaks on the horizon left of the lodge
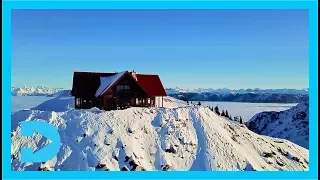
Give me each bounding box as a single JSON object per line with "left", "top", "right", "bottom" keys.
{"left": 11, "top": 86, "right": 63, "bottom": 96}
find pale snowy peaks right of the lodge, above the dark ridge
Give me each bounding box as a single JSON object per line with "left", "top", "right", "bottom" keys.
{"left": 166, "top": 87, "right": 309, "bottom": 95}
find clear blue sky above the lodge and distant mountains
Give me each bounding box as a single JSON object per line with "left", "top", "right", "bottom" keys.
{"left": 11, "top": 10, "right": 309, "bottom": 89}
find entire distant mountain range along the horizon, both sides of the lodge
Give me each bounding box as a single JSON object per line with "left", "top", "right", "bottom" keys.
{"left": 11, "top": 86, "right": 309, "bottom": 103}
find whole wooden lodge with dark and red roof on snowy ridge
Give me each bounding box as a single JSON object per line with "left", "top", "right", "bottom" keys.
{"left": 71, "top": 71, "right": 167, "bottom": 110}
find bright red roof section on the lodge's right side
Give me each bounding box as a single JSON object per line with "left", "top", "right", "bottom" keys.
{"left": 137, "top": 74, "right": 167, "bottom": 96}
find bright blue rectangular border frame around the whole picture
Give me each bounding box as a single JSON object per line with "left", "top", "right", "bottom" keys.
{"left": 2, "top": 0, "right": 318, "bottom": 179}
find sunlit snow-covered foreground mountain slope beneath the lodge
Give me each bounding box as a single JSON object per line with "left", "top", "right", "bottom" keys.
{"left": 11, "top": 97, "right": 309, "bottom": 171}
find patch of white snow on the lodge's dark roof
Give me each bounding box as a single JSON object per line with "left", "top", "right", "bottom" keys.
{"left": 95, "top": 71, "right": 127, "bottom": 97}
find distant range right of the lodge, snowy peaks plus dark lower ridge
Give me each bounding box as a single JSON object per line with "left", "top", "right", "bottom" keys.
{"left": 166, "top": 88, "right": 309, "bottom": 103}
